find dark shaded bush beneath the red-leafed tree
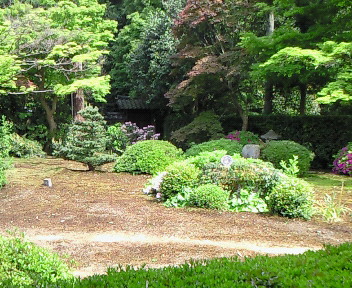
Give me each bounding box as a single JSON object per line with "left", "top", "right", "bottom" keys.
{"left": 170, "top": 111, "right": 223, "bottom": 149}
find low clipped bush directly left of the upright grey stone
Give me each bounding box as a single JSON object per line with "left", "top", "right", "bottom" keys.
{"left": 185, "top": 138, "right": 243, "bottom": 157}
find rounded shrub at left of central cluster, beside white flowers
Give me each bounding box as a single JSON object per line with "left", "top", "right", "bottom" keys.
{"left": 160, "top": 161, "right": 200, "bottom": 200}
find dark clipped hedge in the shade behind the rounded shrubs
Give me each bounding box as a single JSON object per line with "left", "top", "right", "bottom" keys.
{"left": 222, "top": 115, "right": 352, "bottom": 169}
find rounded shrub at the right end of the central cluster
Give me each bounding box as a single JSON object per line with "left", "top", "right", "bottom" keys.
{"left": 267, "top": 176, "right": 313, "bottom": 219}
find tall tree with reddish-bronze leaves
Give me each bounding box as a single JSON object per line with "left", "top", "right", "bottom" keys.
{"left": 165, "top": 0, "right": 266, "bottom": 130}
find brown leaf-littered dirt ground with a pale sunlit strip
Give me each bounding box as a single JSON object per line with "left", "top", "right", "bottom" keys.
{"left": 0, "top": 159, "right": 352, "bottom": 277}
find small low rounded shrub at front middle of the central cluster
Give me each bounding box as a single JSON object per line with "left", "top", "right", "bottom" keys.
{"left": 189, "top": 184, "right": 230, "bottom": 210}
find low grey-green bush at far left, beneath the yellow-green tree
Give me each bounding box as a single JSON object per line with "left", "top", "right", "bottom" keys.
{"left": 10, "top": 133, "right": 45, "bottom": 158}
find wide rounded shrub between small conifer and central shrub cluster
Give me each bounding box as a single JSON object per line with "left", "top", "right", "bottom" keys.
{"left": 114, "top": 140, "right": 184, "bottom": 174}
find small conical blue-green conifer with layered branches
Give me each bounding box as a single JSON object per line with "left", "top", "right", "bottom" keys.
{"left": 54, "top": 106, "right": 116, "bottom": 171}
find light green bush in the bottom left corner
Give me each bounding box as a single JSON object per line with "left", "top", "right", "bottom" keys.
{"left": 0, "top": 236, "right": 72, "bottom": 287}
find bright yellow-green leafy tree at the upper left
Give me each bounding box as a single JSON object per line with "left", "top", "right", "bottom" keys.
{"left": 0, "top": 0, "right": 116, "bottom": 140}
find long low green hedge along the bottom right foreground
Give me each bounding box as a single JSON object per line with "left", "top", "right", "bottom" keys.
{"left": 45, "top": 243, "right": 352, "bottom": 288}
